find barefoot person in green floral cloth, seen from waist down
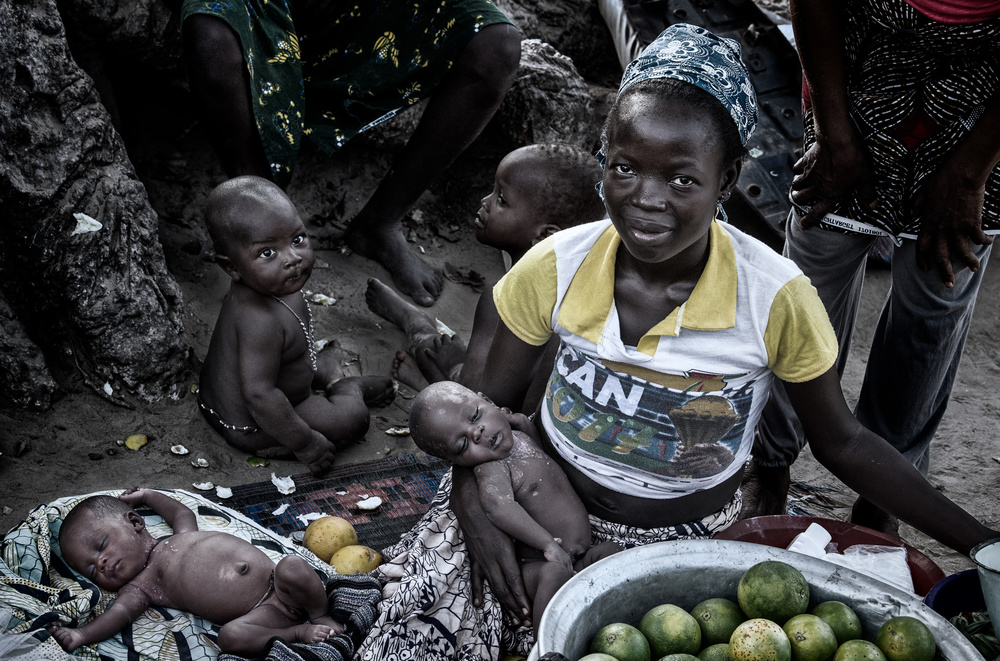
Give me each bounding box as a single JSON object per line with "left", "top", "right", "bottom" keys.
{"left": 181, "top": 0, "right": 521, "bottom": 306}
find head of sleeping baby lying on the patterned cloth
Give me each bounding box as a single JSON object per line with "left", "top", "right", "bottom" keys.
{"left": 59, "top": 496, "right": 156, "bottom": 591}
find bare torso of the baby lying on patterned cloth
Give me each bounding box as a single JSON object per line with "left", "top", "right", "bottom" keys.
{"left": 134, "top": 530, "right": 275, "bottom": 624}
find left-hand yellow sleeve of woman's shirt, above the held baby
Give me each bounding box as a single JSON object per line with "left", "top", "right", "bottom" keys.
{"left": 493, "top": 237, "right": 558, "bottom": 346}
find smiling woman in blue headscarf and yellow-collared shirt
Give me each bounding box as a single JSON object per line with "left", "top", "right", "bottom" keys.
{"left": 362, "top": 24, "right": 1000, "bottom": 659}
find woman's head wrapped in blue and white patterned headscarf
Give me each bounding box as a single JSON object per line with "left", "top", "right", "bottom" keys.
{"left": 598, "top": 24, "right": 757, "bottom": 271}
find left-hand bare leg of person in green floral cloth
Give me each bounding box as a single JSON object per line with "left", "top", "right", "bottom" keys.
{"left": 183, "top": 14, "right": 271, "bottom": 178}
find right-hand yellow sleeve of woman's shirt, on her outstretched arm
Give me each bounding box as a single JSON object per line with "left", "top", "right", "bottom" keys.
{"left": 764, "top": 275, "right": 837, "bottom": 383}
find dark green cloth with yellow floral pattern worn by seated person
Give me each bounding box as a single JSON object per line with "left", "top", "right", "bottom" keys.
{"left": 181, "top": 0, "right": 510, "bottom": 186}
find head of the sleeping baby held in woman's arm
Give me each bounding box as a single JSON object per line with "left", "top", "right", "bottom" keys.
{"left": 410, "top": 381, "right": 514, "bottom": 466}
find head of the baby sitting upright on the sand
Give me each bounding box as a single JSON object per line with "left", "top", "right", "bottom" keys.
{"left": 205, "top": 176, "right": 316, "bottom": 296}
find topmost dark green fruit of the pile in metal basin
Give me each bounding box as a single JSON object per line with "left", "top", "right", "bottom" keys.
{"left": 736, "top": 560, "right": 809, "bottom": 626}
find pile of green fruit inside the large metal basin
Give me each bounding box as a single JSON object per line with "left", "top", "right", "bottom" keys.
{"left": 580, "top": 560, "right": 937, "bottom": 661}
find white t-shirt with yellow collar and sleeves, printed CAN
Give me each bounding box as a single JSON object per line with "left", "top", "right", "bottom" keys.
{"left": 493, "top": 220, "right": 837, "bottom": 499}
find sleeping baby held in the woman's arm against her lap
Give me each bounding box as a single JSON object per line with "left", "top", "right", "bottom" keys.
{"left": 410, "top": 381, "right": 621, "bottom": 629}
